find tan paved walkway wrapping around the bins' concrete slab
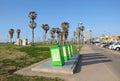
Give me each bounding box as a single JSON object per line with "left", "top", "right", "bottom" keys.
{"left": 15, "top": 45, "right": 119, "bottom": 81}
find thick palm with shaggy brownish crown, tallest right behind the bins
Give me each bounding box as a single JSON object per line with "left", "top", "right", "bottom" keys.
{"left": 61, "top": 22, "right": 69, "bottom": 43}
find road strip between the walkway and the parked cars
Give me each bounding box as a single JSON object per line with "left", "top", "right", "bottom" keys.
{"left": 89, "top": 45, "right": 120, "bottom": 79}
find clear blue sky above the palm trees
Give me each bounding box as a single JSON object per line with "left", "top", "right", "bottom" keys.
{"left": 0, "top": 0, "right": 120, "bottom": 42}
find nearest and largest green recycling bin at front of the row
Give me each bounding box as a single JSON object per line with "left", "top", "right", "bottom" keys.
{"left": 50, "top": 46, "right": 64, "bottom": 66}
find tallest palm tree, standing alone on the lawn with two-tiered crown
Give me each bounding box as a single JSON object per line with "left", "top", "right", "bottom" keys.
{"left": 29, "top": 11, "right": 37, "bottom": 45}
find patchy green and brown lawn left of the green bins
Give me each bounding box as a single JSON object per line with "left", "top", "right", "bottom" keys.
{"left": 0, "top": 44, "right": 62, "bottom": 81}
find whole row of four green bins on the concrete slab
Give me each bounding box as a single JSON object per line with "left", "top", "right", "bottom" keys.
{"left": 50, "top": 44, "right": 74, "bottom": 66}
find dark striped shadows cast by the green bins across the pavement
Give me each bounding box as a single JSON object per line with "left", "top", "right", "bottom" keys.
{"left": 74, "top": 53, "right": 112, "bottom": 73}
